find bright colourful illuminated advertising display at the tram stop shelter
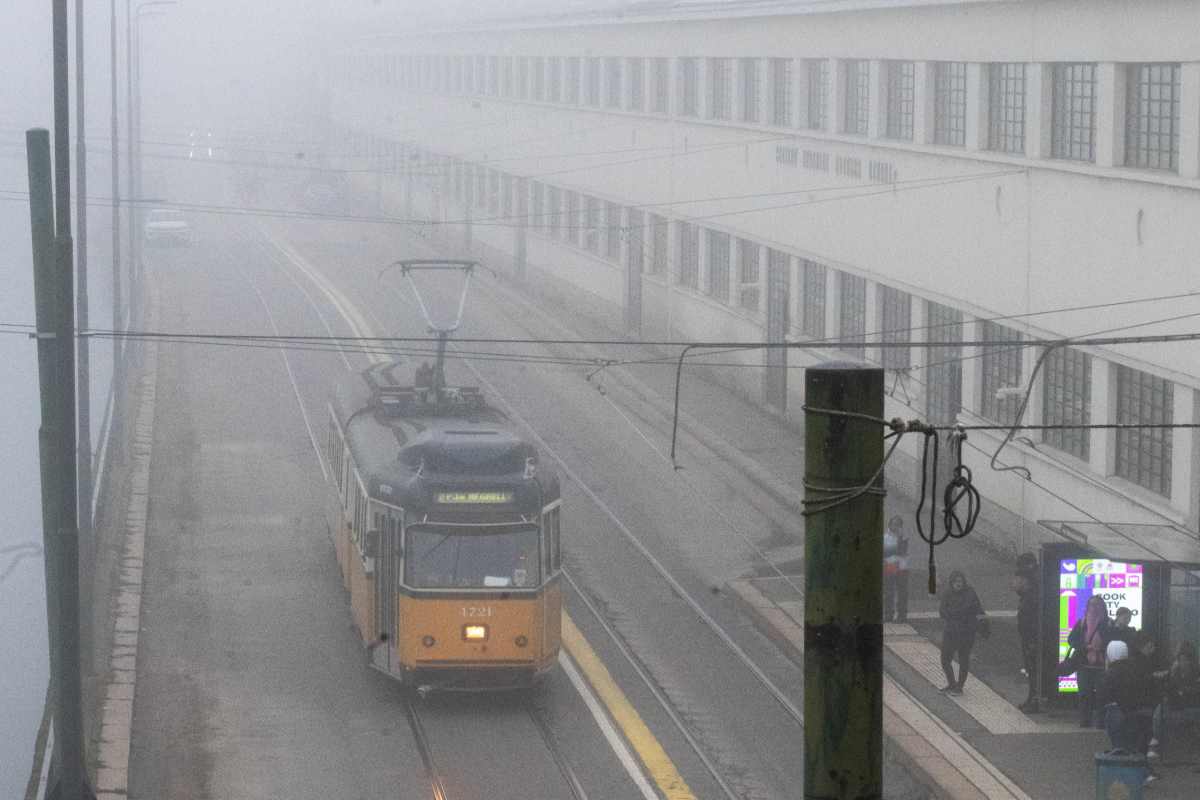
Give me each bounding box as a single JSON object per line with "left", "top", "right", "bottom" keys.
{"left": 1058, "top": 559, "right": 1145, "bottom": 693}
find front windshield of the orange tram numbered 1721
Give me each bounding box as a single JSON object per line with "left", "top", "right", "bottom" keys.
{"left": 404, "top": 525, "right": 541, "bottom": 589}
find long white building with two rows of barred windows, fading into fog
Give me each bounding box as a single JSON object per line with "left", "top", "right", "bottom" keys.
{"left": 326, "top": 0, "right": 1200, "bottom": 561}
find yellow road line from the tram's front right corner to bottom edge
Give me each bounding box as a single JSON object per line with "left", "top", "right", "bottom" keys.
{"left": 563, "top": 612, "right": 696, "bottom": 800}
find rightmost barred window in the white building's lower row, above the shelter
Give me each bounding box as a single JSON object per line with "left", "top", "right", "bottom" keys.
{"left": 1116, "top": 365, "right": 1175, "bottom": 498}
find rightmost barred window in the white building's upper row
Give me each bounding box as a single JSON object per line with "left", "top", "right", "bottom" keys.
{"left": 1126, "top": 64, "right": 1180, "bottom": 172}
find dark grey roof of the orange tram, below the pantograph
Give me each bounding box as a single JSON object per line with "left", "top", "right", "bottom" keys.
{"left": 334, "top": 360, "right": 559, "bottom": 513}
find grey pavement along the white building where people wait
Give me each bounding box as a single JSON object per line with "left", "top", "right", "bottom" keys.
{"left": 465, "top": 271, "right": 1200, "bottom": 800}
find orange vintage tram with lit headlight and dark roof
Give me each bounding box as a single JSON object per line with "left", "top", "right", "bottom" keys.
{"left": 326, "top": 359, "right": 563, "bottom": 694}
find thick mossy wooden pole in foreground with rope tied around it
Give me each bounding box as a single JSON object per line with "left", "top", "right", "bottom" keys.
{"left": 804, "top": 362, "right": 883, "bottom": 800}
